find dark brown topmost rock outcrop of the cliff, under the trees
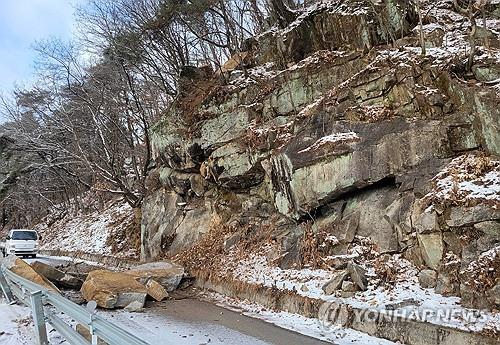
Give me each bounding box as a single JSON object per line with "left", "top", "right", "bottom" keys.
{"left": 259, "top": 0, "right": 416, "bottom": 63}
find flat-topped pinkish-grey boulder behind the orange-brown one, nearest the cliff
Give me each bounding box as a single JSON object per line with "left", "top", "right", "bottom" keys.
{"left": 125, "top": 261, "right": 184, "bottom": 292}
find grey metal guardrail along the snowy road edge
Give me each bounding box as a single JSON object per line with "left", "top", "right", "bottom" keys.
{"left": 0, "top": 266, "right": 148, "bottom": 345}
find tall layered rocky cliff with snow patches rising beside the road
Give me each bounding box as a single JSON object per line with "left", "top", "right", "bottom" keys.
{"left": 141, "top": 0, "right": 500, "bottom": 308}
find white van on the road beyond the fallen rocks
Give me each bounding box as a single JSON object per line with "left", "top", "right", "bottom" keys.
{"left": 0, "top": 229, "right": 41, "bottom": 258}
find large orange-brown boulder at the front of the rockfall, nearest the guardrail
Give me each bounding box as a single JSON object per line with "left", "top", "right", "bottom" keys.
{"left": 80, "top": 270, "right": 148, "bottom": 309}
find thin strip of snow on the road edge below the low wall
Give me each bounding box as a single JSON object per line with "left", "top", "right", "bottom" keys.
{"left": 205, "top": 293, "right": 395, "bottom": 345}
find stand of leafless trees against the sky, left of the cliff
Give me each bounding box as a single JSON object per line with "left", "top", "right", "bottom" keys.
{"left": 0, "top": 0, "right": 304, "bottom": 227}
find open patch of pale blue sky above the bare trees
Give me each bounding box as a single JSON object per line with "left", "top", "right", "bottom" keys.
{"left": 0, "top": 0, "right": 80, "bottom": 92}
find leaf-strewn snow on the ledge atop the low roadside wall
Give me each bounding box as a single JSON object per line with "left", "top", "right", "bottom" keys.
{"left": 224, "top": 243, "right": 500, "bottom": 331}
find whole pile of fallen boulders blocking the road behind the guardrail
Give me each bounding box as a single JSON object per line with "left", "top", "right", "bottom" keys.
{"left": 3, "top": 255, "right": 184, "bottom": 311}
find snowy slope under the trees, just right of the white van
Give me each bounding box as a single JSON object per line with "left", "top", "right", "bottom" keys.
{"left": 35, "top": 198, "right": 137, "bottom": 257}
